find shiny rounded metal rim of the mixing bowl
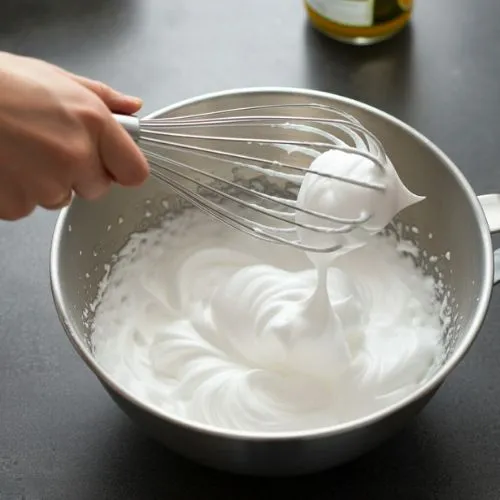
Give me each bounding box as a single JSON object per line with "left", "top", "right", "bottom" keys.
{"left": 50, "top": 86, "right": 494, "bottom": 442}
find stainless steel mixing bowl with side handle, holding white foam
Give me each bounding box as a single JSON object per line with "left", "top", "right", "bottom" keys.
{"left": 50, "top": 88, "right": 500, "bottom": 475}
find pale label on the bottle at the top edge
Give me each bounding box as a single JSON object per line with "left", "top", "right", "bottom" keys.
{"left": 307, "top": 0, "right": 375, "bottom": 27}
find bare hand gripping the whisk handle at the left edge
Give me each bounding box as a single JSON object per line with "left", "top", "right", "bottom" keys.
{"left": 0, "top": 52, "right": 148, "bottom": 220}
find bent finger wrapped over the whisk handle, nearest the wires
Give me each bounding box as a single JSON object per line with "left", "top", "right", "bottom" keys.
{"left": 99, "top": 115, "right": 149, "bottom": 186}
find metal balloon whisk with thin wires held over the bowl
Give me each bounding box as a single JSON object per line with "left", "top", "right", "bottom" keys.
{"left": 115, "top": 103, "right": 388, "bottom": 252}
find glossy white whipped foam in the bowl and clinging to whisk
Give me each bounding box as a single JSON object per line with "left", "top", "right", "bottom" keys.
{"left": 92, "top": 162, "right": 442, "bottom": 433}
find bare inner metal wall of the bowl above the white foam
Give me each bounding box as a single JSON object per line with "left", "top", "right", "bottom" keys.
{"left": 52, "top": 90, "right": 491, "bottom": 402}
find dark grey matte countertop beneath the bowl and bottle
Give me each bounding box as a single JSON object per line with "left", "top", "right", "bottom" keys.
{"left": 0, "top": 0, "right": 500, "bottom": 500}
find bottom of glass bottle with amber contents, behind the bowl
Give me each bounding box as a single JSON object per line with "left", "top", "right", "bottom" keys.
{"left": 305, "top": 0, "right": 413, "bottom": 45}
